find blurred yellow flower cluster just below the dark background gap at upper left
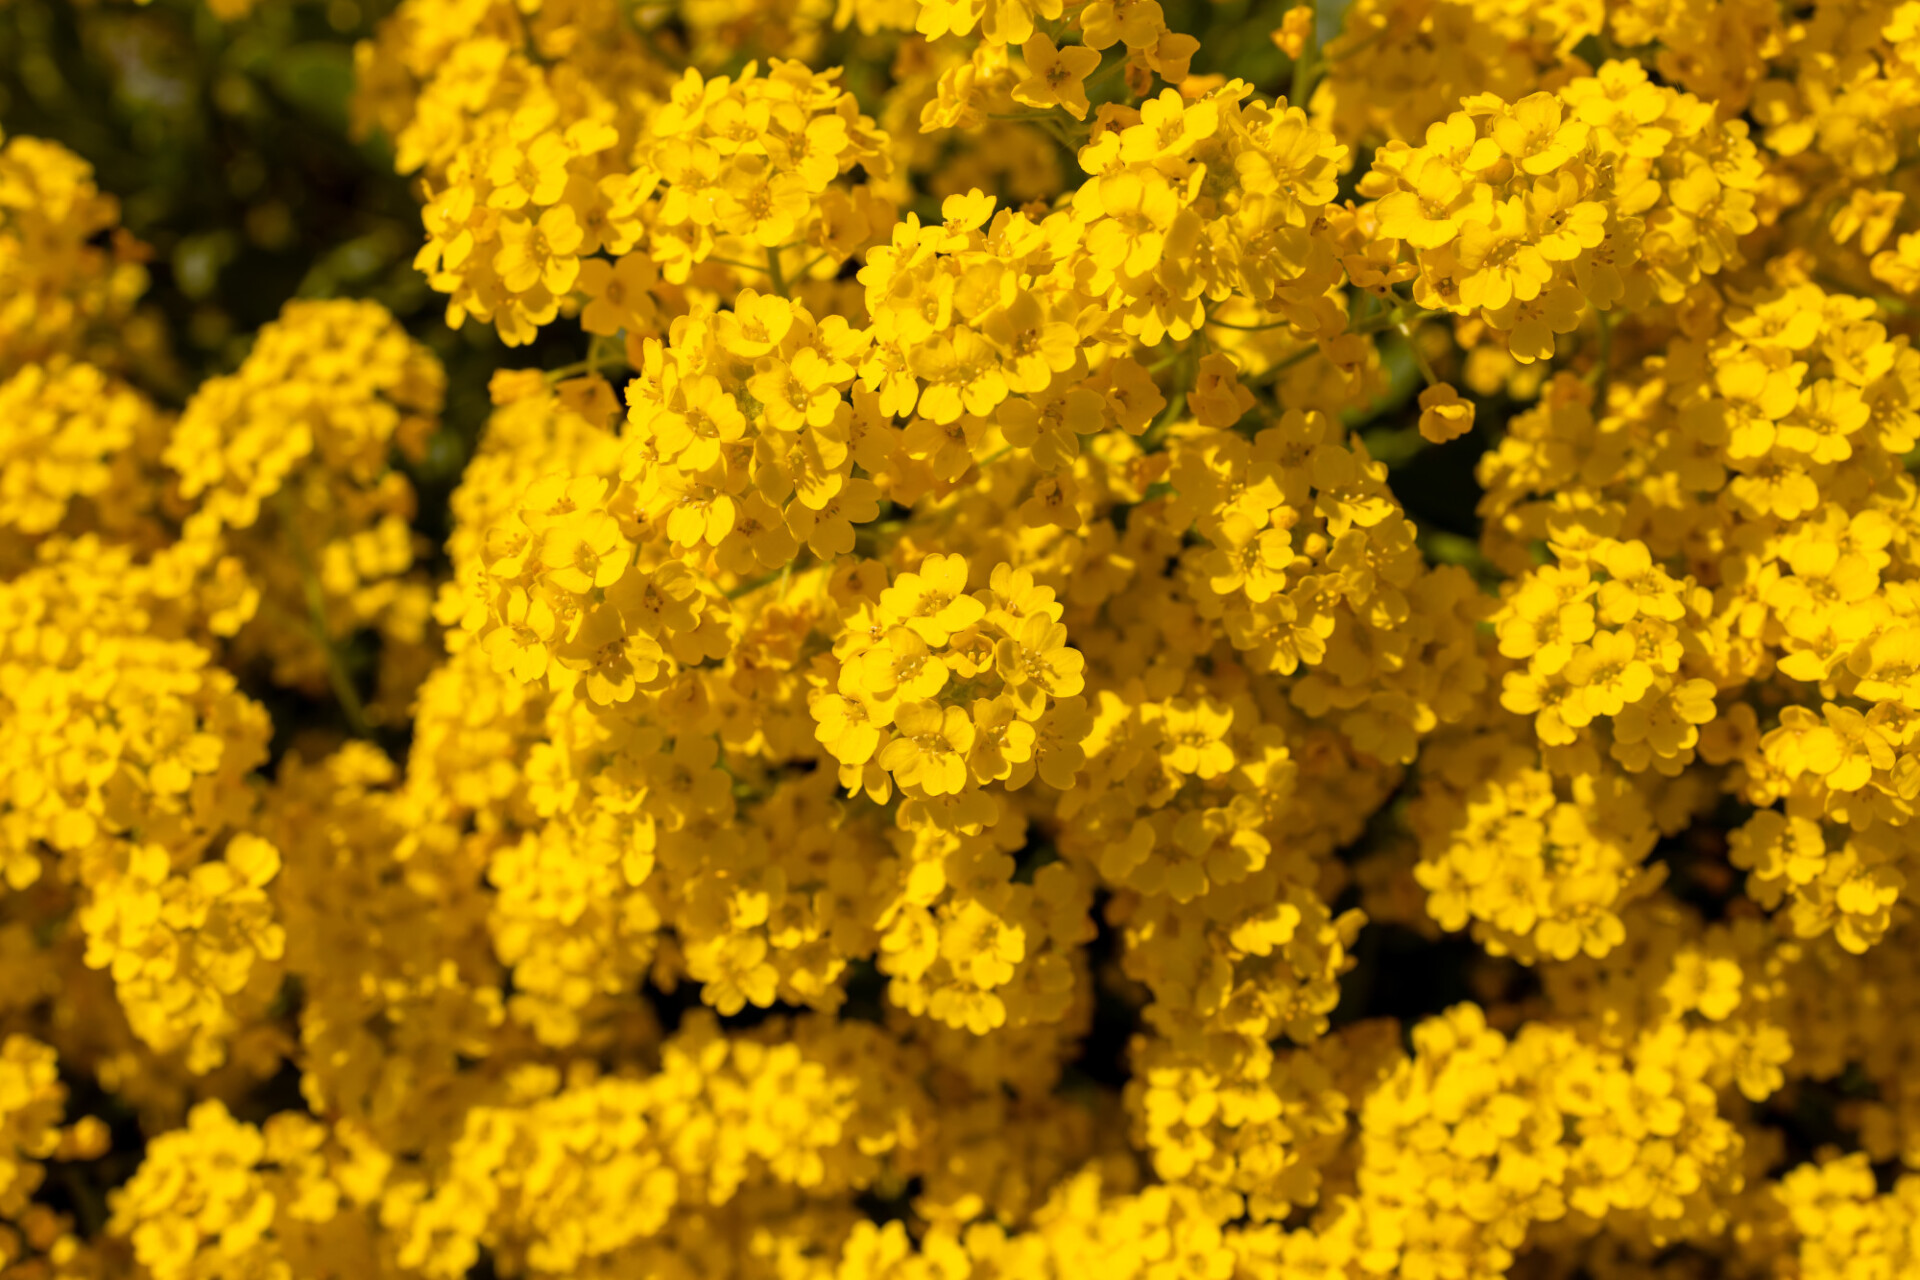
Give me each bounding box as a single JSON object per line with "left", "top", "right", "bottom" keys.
{"left": 161, "top": 301, "right": 444, "bottom": 706}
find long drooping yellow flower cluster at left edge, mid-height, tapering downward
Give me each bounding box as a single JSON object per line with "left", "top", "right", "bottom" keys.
{"left": 0, "top": 537, "right": 284, "bottom": 1069}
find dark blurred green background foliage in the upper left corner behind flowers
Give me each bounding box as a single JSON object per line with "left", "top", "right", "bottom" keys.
{"left": 0, "top": 0, "right": 501, "bottom": 560}
